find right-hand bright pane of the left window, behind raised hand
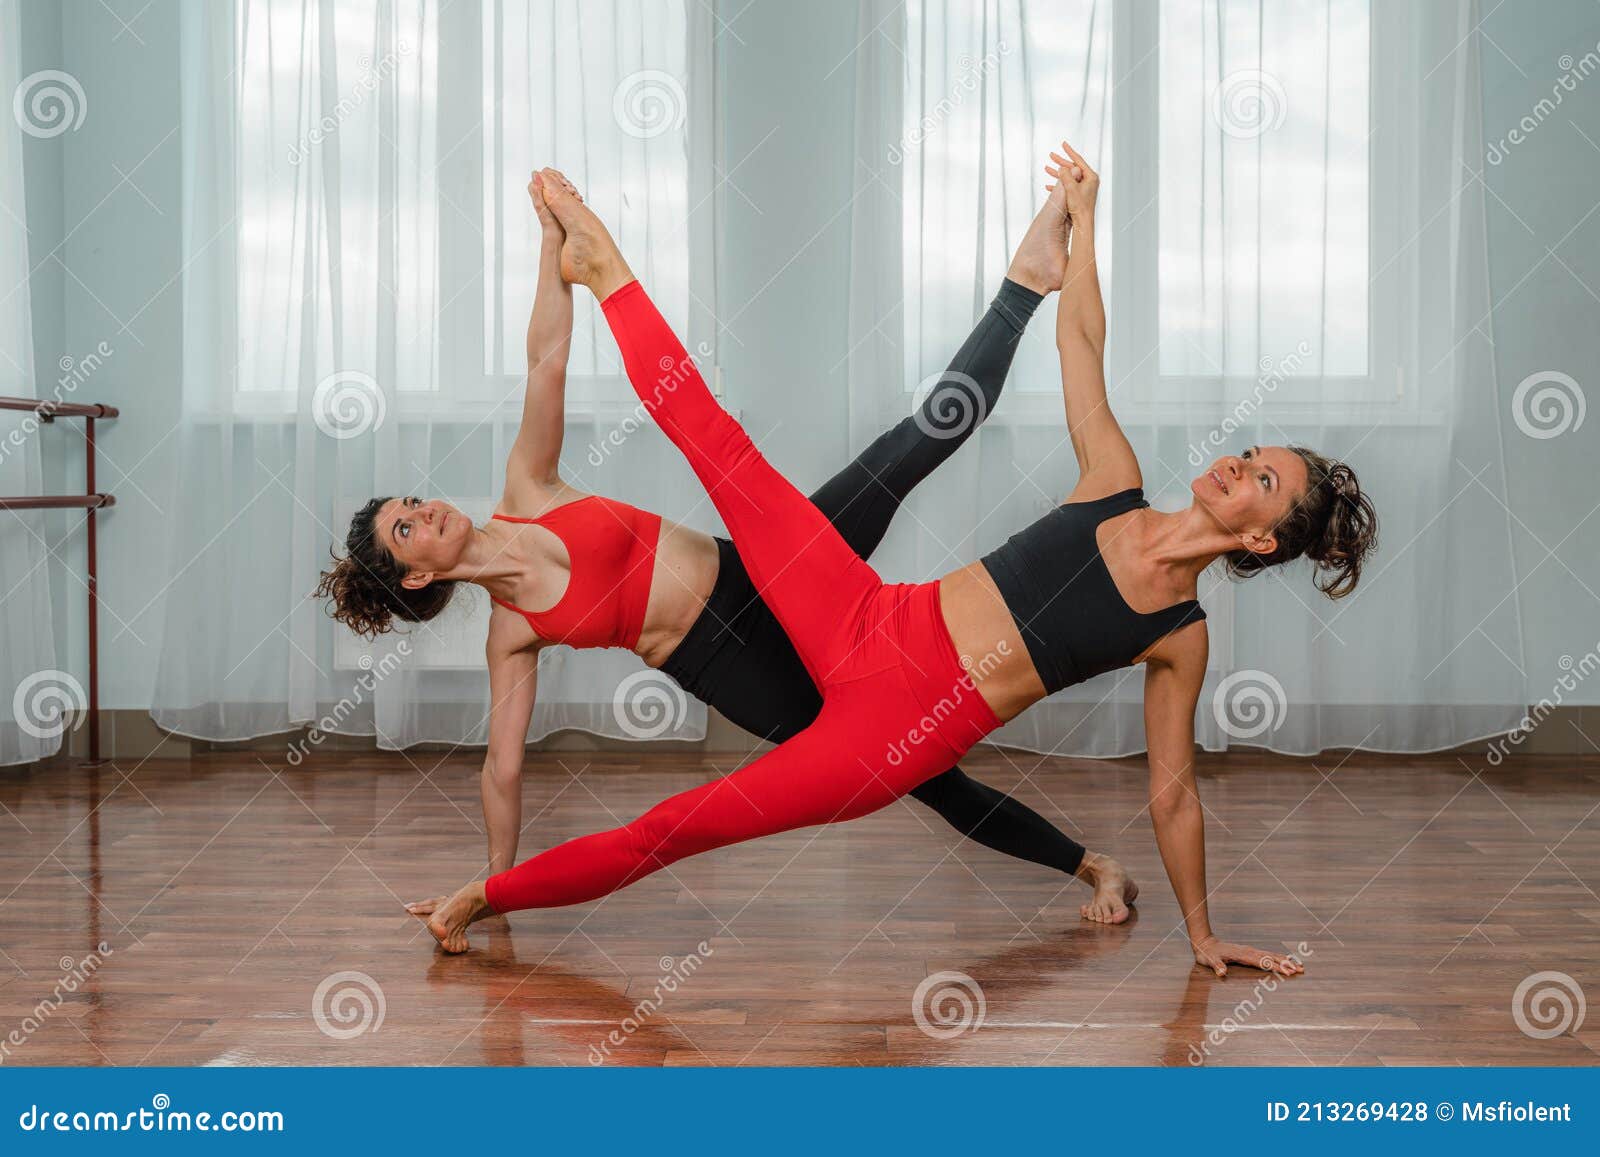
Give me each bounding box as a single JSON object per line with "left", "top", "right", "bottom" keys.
{"left": 472, "top": 0, "right": 690, "bottom": 388}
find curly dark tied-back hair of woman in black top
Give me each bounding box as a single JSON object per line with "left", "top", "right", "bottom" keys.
{"left": 1226, "top": 446, "right": 1378, "bottom": 599}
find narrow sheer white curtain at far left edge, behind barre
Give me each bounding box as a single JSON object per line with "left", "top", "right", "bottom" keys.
{"left": 0, "top": 0, "right": 63, "bottom": 765}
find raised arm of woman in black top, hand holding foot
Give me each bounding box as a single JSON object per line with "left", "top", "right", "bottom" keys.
{"left": 1045, "top": 142, "right": 1142, "bottom": 499}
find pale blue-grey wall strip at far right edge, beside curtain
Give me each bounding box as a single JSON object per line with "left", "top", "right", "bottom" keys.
{"left": 1483, "top": 0, "right": 1600, "bottom": 700}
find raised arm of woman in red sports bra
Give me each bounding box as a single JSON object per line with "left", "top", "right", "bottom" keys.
{"left": 506, "top": 173, "right": 573, "bottom": 486}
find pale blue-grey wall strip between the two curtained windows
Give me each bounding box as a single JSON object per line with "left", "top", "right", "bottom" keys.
{"left": 717, "top": 0, "right": 859, "bottom": 491}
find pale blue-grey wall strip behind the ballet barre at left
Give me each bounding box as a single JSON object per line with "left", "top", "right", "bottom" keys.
{"left": 22, "top": 0, "right": 182, "bottom": 707}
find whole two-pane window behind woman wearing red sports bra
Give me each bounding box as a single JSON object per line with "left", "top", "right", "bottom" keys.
{"left": 235, "top": 0, "right": 700, "bottom": 413}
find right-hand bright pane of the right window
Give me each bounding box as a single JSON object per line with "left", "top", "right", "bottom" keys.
{"left": 1158, "top": 0, "right": 1370, "bottom": 378}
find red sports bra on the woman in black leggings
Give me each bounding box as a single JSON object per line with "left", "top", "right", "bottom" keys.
{"left": 490, "top": 494, "right": 661, "bottom": 650}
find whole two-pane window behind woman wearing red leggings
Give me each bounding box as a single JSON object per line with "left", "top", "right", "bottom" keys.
{"left": 899, "top": 0, "right": 1418, "bottom": 422}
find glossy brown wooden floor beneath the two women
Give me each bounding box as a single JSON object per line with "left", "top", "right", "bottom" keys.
{"left": 0, "top": 752, "right": 1600, "bottom": 1066}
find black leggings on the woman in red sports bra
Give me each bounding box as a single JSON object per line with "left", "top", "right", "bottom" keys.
{"left": 661, "top": 280, "right": 1083, "bottom": 872}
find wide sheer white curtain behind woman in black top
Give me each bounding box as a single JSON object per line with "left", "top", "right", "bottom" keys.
{"left": 850, "top": 0, "right": 1526, "bottom": 755}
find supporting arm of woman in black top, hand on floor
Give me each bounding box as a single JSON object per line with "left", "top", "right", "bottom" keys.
{"left": 1144, "top": 631, "right": 1302, "bottom": 976}
